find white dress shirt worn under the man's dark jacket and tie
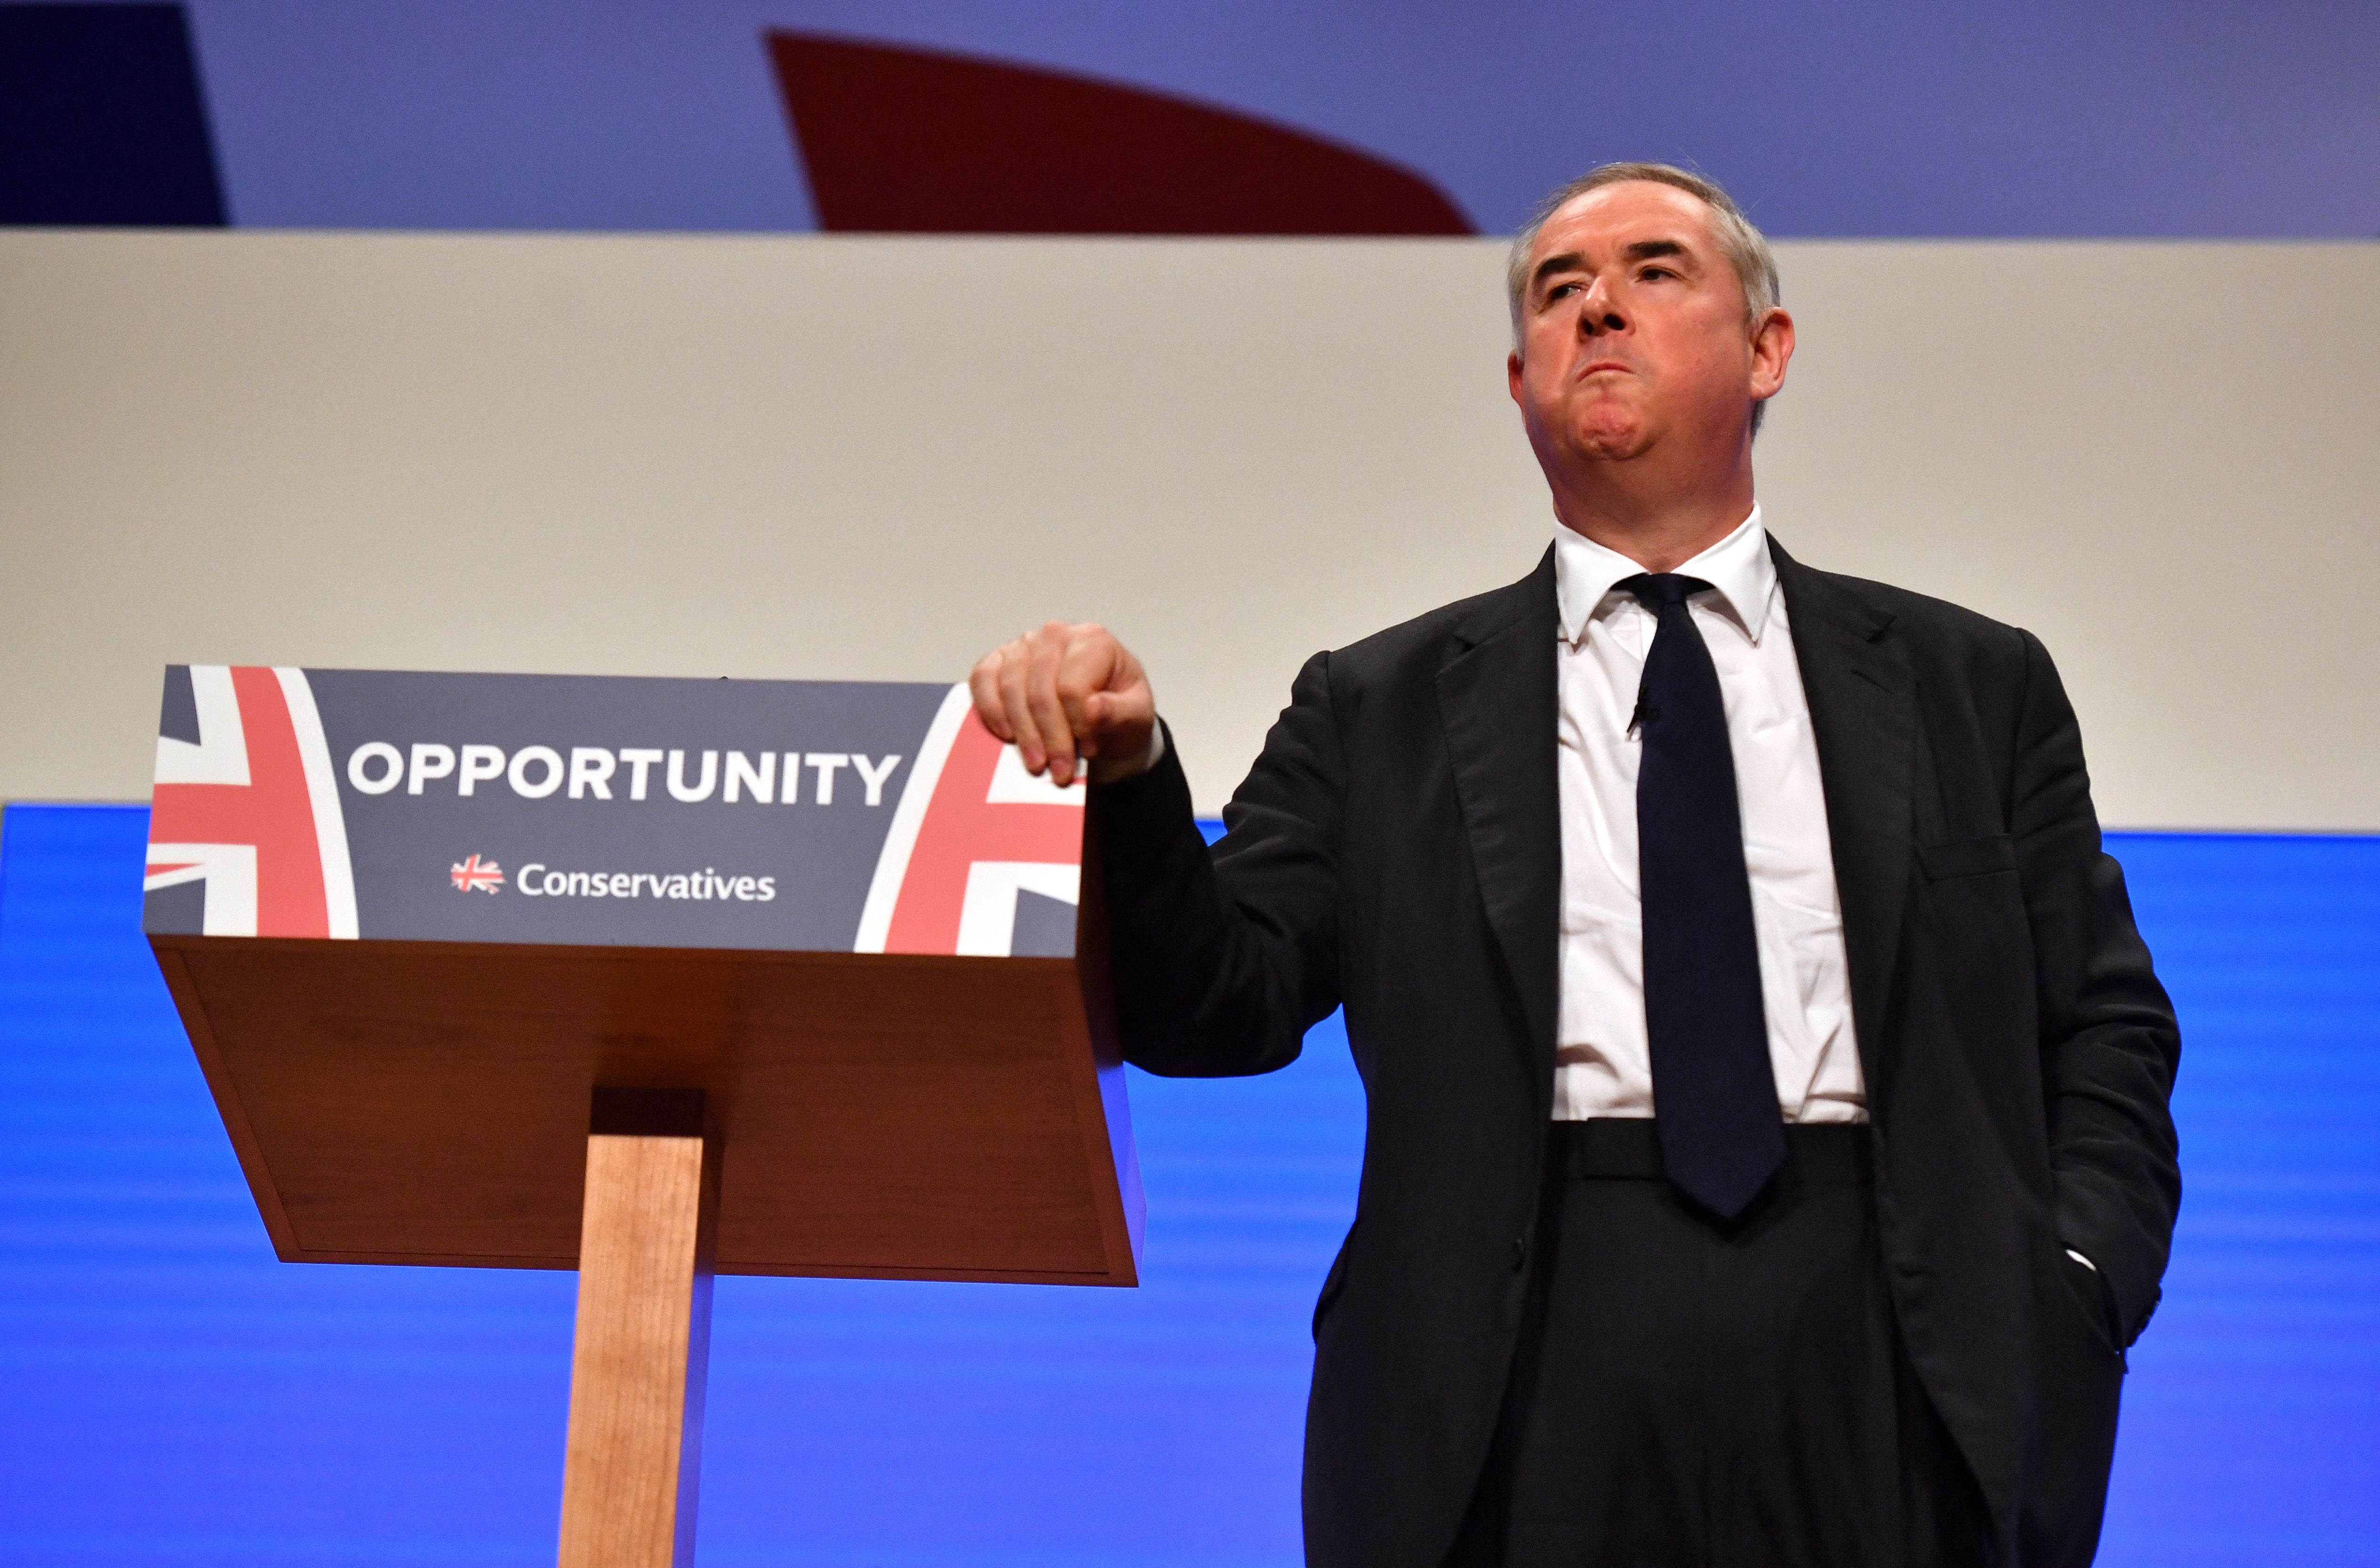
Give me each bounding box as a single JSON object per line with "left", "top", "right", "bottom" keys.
{"left": 1554, "top": 507, "right": 1868, "bottom": 1121}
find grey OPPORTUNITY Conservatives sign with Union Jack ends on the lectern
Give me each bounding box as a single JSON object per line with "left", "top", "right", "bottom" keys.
{"left": 145, "top": 664, "right": 1083, "bottom": 957}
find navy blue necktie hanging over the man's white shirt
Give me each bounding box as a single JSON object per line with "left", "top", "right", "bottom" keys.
{"left": 1618, "top": 571, "right": 1785, "bottom": 1218}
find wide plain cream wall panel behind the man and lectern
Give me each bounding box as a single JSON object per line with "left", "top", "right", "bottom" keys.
{"left": 0, "top": 231, "right": 2380, "bottom": 830}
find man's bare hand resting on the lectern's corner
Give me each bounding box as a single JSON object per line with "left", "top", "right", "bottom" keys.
{"left": 966, "top": 621, "right": 1157, "bottom": 785}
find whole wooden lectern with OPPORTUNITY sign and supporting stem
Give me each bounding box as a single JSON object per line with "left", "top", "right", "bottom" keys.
{"left": 145, "top": 666, "right": 1140, "bottom": 1563}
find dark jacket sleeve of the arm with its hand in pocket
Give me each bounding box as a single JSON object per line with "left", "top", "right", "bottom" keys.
{"left": 2009, "top": 633, "right": 2183, "bottom": 1344}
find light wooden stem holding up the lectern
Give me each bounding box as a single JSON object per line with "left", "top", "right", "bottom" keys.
{"left": 559, "top": 1090, "right": 719, "bottom": 1568}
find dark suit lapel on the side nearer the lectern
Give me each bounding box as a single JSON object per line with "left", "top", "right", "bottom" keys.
{"left": 1437, "top": 550, "right": 1561, "bottom": 1095}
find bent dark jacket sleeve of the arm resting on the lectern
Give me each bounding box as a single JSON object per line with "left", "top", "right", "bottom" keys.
{"left": 1090, "top": 654, "right": 1345, "bottom": 1078}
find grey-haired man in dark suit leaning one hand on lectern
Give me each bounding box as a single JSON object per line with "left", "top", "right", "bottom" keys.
{"left": 973, "top": 164, "right": 2180, "bottom": 1568}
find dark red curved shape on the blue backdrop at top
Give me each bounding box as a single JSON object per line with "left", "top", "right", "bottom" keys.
{"left": 769, "top": 33, "right": 1473, "bottom": 233}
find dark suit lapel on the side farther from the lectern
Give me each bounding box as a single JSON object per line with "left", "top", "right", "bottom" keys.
{"left": 1768, "top": 540, "right": 1916, "bottom": 1095}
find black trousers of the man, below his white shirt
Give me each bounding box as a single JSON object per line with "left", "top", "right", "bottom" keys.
{"left": 1447, "top": 1121, "right": 1990, "bottom": 1568}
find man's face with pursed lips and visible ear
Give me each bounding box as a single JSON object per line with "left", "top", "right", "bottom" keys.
{"left": 1507, "top": 181, "right": 1792, "bottom": 476}
